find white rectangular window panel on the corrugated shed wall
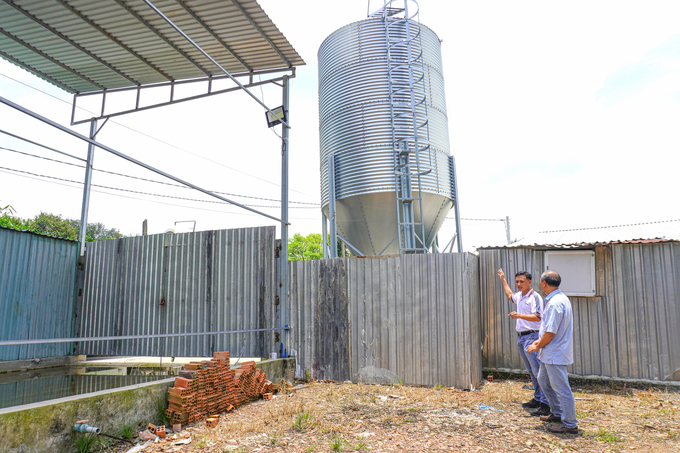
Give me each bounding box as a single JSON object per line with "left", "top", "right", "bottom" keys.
{"left": 545, "top": 250, "right": 595, "bottom": 297}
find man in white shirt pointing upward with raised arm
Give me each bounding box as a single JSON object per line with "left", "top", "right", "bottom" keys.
{"left": 498, "top": 269, "right": 550, "bottom": 417}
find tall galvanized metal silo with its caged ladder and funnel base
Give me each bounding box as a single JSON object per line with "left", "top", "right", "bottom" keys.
{"left": 318, "top": 2, "right": 460, "bottom": 255}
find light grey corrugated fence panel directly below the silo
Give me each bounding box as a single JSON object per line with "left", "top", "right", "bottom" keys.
{"left": 349, "top": 254, "right": 481, "bottom": 388}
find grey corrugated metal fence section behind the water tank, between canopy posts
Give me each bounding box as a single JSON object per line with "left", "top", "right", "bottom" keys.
{"left": 77, "top": 226, "right": 276, "bottom": 357}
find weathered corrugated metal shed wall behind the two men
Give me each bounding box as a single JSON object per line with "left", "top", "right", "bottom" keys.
{"left": 479, "top": 242, "right": 680, "bottom": 381}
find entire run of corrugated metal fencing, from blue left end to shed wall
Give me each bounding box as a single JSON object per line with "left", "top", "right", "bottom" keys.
{"left": 7, "top": 221, "right": 680, "bottom": 387}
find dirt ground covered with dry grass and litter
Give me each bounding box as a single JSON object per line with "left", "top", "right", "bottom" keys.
{"left": 117, "top": 380, "right": 680, "bottom": 453}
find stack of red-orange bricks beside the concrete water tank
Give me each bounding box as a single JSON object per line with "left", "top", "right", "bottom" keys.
{"left": 165, "top": 352, "right": 277, "bottom": 426}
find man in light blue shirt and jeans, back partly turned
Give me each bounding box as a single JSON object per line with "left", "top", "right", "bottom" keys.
{"left": 527, "top": 271, "right": 578, "bottom": 434}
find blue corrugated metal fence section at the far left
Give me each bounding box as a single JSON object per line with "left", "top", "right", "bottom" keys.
{"left": 0, "top": 228, "right": 78, "bottom": 360}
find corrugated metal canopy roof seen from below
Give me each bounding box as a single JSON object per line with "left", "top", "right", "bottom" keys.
{"left": 0, "top": 0, "right": 305, "bottom": 94}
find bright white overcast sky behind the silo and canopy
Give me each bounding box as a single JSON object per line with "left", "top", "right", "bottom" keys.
{"left": 0, "top": 0, "right": 680, "bottom": 250}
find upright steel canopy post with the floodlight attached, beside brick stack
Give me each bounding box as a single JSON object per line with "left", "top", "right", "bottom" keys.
{"left": 278, "top": 76, "right": 290, "bottom": 357}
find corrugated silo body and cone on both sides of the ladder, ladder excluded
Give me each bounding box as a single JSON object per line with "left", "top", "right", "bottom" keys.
{"left": 318, "top": 18, "right": 454, "bottom": 255}
